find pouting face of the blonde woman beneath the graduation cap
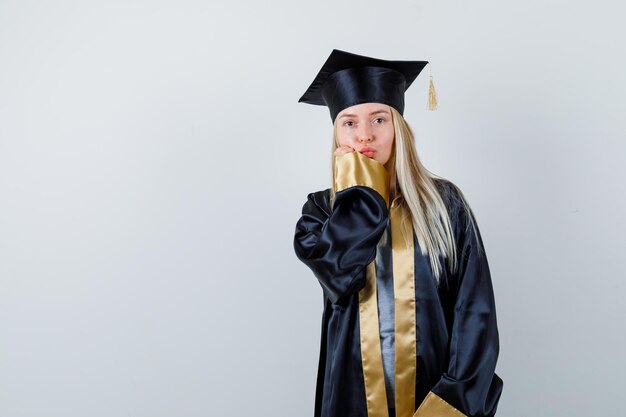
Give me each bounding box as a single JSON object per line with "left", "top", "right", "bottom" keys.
{"left": 337, "top": 103, "right": 395, "bottom": 165}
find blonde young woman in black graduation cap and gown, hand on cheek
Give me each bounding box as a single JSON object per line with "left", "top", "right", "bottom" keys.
{"left": 294, "top": 50, "right": 503, "bottom": 417}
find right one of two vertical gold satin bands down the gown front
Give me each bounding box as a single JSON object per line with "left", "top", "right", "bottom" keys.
{"left": 390, "top": 200, "right": 416, "bottom": 417}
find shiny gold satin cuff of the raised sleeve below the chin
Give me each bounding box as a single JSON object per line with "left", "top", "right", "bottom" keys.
{"left": 335, "top": 151, "right": 389, "bottom": 208}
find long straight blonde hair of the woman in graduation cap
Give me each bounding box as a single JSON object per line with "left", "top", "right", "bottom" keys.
{"left": 330, "top": 106, "right": 475, "bottom": 284}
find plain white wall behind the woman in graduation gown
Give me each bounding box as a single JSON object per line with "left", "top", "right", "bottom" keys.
{"left": 0, "top": 0, "right": 626, "bottom": 417}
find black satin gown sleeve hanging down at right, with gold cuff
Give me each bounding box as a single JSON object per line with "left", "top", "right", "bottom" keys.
{"left": 414, "top": 184, "right": 503, "bottom": 417}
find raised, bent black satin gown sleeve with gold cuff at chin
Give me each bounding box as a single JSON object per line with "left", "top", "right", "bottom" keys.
{"left": 294, "top": 151, "right": 389, "bottom": 304}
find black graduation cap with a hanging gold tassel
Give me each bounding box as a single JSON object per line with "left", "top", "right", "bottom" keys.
{"left": 298, "top": 49, "right": 437, "bottom": 122}
